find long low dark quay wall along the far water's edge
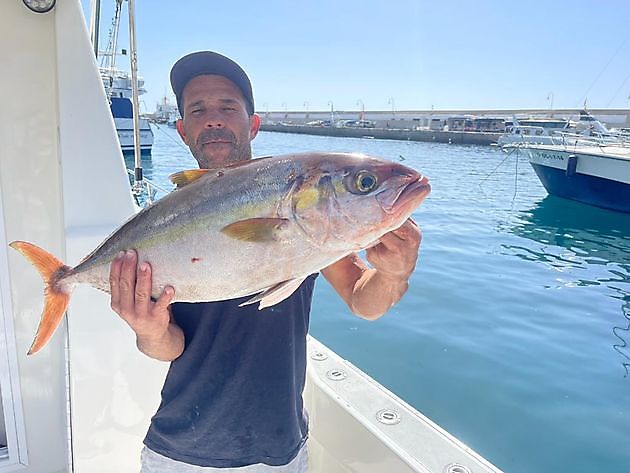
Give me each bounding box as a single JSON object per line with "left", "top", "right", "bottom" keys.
{"left": 260, "top": 124, "right": 502, "bottom": 145}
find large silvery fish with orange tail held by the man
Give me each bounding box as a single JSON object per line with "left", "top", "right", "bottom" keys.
{"left": 11, "top": 153, "right": 430, "bottom": 354}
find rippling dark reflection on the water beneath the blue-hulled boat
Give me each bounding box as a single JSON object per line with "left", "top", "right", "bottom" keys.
{"left": 503, "top": 196, "right": 630, "bottom": 377}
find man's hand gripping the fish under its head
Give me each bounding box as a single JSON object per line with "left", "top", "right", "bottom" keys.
{"left": 365, "top": 219, "right": 422, "bottom": 282}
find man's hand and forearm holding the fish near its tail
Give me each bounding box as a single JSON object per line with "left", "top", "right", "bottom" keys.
{"left": 109, "top": 250, "right": 184, "bottom": 361}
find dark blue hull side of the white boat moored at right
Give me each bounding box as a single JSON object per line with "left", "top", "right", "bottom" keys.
{"left": 531, "top": 163, "right": 630, "bottom": 213}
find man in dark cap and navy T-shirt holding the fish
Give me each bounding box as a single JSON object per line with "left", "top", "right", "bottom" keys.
{"left": 110, "top": 51, "right": 421, "bottom": 473}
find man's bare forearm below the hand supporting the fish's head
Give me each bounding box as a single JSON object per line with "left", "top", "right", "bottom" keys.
{"left": 349, "top": 268, "right": 409, "bottom": 320}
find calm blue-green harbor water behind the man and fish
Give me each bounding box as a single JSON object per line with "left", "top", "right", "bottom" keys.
{"left": 135, "top": 127, "right": 630, "bottom": 473}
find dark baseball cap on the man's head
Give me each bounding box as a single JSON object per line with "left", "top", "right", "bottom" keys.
{"left": 171, "top": 51, "right": 254, "bottom": 117}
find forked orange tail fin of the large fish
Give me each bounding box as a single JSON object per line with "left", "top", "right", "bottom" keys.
{"left": 9, "top": 241, "right": 71, "bottom": 355}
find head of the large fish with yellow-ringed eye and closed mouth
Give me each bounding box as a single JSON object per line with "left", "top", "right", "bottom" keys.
{"left": 291, "top": 153, "right": 431, "bottom": 251}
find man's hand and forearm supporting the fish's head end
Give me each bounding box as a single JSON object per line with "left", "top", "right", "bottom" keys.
{"left": 322, "top": 219, "right": 422, "bottom": 320}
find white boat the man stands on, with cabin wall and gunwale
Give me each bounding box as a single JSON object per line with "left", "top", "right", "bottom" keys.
{"left": 0, "top": 0, "right": 499, "bottom": 473}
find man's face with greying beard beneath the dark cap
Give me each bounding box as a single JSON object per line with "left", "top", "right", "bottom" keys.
{"left": 177, "top": 75, "right": 260, "bottom": 168}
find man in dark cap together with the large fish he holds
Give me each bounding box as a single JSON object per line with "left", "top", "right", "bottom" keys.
{"left": 11, "top": 51, "right": 430, "bottom": 473}
